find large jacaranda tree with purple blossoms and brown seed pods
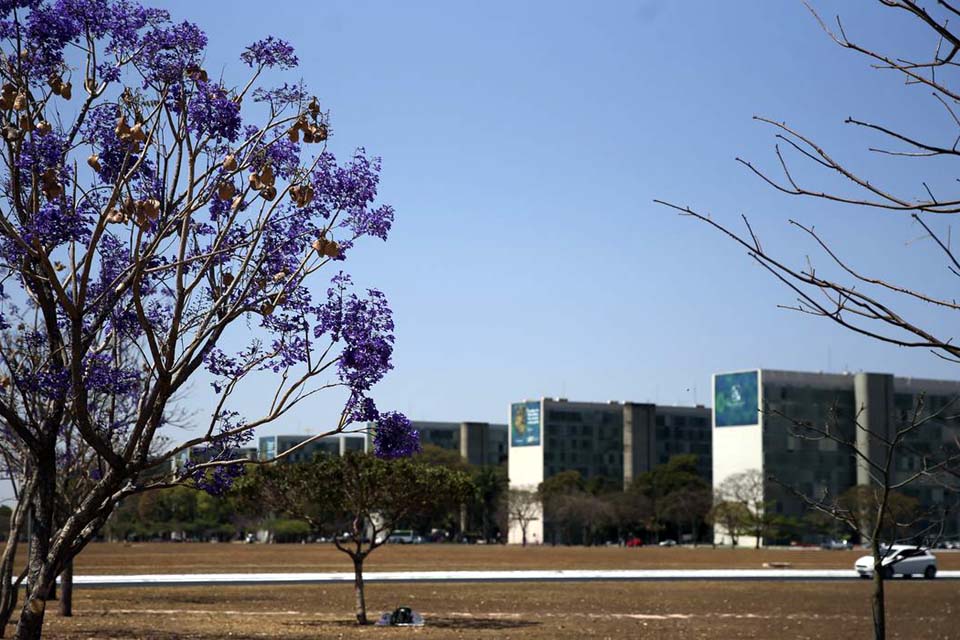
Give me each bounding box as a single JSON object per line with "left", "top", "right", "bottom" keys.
{"left": 0, "top": 0, "right": 416, "bottom": 639}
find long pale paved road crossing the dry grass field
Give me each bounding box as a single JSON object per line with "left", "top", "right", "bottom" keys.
{"left": 73, "top": 569, "right": 960, "bottom": 587}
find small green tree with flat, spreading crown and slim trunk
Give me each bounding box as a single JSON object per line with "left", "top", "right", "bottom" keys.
{"left": 241, "top": 452, "right": 474, "bottom": 624}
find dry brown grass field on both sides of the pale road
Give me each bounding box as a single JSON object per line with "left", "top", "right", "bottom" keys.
{"left": 18, "top": 544, "right": 960, "bottom": 640}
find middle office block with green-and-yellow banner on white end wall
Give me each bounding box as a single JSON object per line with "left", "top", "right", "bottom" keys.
{"left": 508, "top": 398, "right": 711, "bottom": 543}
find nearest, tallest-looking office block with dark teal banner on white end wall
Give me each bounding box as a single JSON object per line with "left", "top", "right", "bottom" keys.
{"left": 712, "top": 369, "right": 960, "bottom": 545}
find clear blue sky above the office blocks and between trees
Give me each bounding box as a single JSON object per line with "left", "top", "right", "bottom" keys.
{"left": 150, "top": 0, "right": 957, "bottom": 433}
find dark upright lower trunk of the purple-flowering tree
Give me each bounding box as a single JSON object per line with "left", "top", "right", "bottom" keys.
{"left": 14, "top": 450, "right": 56, "bottom": 640}
